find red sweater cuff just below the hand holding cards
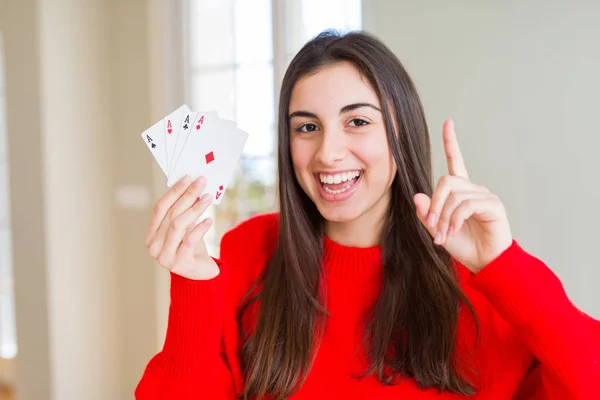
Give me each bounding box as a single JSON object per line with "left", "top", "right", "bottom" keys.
{"left": 163, "top": 259, "right": 227, "bottom": 377}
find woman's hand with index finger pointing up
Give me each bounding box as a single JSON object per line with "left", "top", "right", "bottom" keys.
{"left": 414, "top": 120, "right": 512, "bottom": 273}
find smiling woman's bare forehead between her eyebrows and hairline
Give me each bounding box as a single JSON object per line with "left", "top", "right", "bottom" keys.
{"left": 289, "top": 62, "right": 381, "bottom": 114}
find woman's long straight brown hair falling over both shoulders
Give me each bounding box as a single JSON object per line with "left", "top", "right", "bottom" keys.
{"left": 238, "top": 31, "right": 475, "bottom": 399}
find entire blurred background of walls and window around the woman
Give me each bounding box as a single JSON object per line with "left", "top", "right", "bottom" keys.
{"left": 0, "top": 0, "right": 600, "bottom": 400}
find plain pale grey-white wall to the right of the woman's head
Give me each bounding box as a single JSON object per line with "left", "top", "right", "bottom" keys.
{"left": 363, "top": 0, "right": 600, "bottom": 318}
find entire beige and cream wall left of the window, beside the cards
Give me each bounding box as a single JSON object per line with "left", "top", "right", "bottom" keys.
{"left": 0, "top": 0, "right": 168, "bottom": 400}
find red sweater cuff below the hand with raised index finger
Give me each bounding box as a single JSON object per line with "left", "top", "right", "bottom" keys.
{"left": 468, "top": 240, "right": 569, "bottom": 327}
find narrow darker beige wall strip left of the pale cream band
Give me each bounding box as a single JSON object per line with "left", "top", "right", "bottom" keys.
{"left": 0, "top": 0, "right": 53, "bottom": 399}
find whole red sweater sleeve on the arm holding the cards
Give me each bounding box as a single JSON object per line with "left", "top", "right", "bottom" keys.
{"left": 135, "top": 260, "right": 235, "bottom": 400}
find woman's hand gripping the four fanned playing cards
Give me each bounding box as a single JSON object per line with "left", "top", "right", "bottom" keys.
{"left": 145, "top": 176, "right": 220, "bottom": 280}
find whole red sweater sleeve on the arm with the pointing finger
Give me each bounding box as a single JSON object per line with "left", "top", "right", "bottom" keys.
{"left": 469, "top": 241, "right": 600, "bottom": 399}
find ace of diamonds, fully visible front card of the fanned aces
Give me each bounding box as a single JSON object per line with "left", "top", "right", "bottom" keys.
{"left": 168, "top": 113, "right": 248, "bottom": 204}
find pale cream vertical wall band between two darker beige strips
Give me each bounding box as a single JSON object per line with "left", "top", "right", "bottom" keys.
{"left": 38, "top": 0, "right": 120, "bottom": 400}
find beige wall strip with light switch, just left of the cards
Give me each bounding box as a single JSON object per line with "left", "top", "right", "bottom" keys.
{"left": 106, "top": 0, "right": 164, "bottom": 399}
